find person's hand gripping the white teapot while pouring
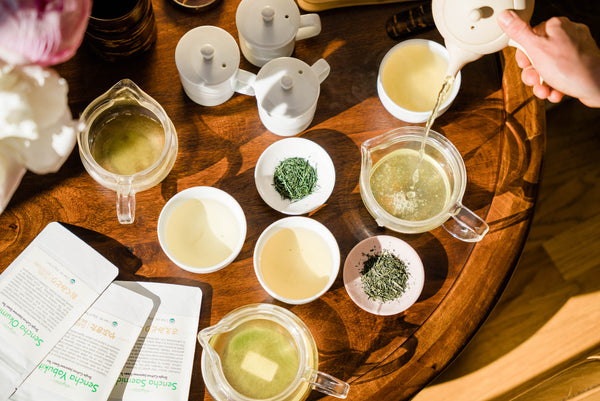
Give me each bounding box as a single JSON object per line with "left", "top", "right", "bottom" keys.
{"left": 498, "top": 10, "right": 600, "bottom": 107}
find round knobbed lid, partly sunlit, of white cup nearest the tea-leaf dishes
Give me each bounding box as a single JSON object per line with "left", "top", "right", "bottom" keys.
{"left": 254, "top": 57, "right": 320, "bottom": 118}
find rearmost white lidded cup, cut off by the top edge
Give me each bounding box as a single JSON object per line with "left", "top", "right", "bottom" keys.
{"left": 235, "top": 0, "right": 321, "bottom": 67}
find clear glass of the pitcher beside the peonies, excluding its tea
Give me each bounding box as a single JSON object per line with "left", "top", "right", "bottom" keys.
{"left": 77, "top": 79, "right": 178, "bottom": 224}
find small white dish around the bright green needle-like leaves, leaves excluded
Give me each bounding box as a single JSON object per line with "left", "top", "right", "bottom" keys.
{"left": 254, "top": 138, "right": 335, "bottom": 215}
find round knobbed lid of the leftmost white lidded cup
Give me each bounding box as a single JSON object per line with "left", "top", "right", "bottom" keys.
{"left": 175, "top": 25, "right": 240, "bottom": 85}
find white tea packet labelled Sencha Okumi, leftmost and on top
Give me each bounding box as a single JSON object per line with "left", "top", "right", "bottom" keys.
{"left": 0, "top": 222, "right": 119, "bottom": 400}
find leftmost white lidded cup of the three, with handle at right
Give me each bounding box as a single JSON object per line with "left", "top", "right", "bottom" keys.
{"left": 175, "top": 25, "right": 254, "bottom": 106}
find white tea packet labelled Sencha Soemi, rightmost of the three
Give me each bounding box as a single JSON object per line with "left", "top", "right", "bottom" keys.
{"left": 109, "top": 281, "right": 202, "bottom": 401}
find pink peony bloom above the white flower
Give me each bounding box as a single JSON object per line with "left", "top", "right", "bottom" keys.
{"left": 0, "top": 0, "right": 92, "bottom": 66}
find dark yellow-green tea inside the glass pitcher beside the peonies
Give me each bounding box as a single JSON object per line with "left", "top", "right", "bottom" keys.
{"left": 90, "top": 109, "right": 165, "bottom": 175}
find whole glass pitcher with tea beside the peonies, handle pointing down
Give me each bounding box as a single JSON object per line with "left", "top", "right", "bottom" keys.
{"left": 77, "top": 79, "right": 178, "bottom": 224}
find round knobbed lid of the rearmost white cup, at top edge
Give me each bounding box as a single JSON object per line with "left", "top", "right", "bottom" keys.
{"left": 235, "top": 0, "right": 300, "bottom": 48}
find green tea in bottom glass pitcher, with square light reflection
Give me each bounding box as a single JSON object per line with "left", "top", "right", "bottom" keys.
{"left": 210, "top": 319, "right": 299, "bottom": 399}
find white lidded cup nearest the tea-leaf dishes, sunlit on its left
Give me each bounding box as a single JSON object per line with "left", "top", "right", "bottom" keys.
{"left": 254, "top": 57, "right": 330, "bottom": 136}
